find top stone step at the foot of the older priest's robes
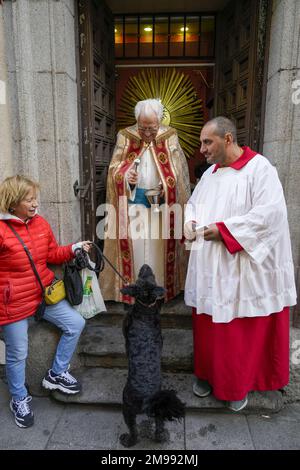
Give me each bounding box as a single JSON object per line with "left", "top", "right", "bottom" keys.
{"left": 88, "top": 295, "right": 192, "bottom": 329}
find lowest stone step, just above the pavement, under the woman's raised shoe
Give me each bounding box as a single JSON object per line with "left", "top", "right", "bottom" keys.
{"left": 52, "top": 367, "right": 283, "bottom": 414}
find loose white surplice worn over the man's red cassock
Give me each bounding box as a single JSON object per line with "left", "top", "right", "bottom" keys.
{"left": 185, "top": 154, "right": 296, "bottom": 323}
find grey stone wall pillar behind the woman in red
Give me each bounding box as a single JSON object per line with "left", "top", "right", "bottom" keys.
{"left": 0, "top": 0, "right": 81, "bottom": 243}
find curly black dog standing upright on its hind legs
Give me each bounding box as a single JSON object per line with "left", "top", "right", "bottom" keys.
{"left": 120, "top": 264, "right": 185, "bottom": 447}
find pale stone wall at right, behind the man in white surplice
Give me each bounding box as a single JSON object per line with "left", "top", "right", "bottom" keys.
{"left": 263, "top": 0, "right": 300, "bottom": 302}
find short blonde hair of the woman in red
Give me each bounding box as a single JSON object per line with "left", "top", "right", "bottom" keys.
{"left": 0, "top": 175, "right": 40, "bottom": 213}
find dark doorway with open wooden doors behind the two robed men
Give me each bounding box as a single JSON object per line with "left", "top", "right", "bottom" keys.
{"left": 74, "top": 0, "right": 270, "bottom": 239}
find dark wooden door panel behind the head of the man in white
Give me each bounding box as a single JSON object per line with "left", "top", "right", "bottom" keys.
{"left": 216, "top": 0, "right": 268, "bottom": 151}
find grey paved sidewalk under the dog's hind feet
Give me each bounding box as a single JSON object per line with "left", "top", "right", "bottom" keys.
{"left": 0, "top": 379, "right": 300, "bottom": 451}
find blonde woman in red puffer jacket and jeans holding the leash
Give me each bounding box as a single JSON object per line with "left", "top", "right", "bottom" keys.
{"left": 0, "top": 175, "right": 90, "bottom": 428}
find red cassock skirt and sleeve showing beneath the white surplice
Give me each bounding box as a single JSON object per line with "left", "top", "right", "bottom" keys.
{"left": 193, "top": 197, "right": 289, "bottom": 401}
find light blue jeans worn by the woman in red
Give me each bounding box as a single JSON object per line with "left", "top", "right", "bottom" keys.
{"left": 2, "top": 300, "right": 85, "bottom": 400}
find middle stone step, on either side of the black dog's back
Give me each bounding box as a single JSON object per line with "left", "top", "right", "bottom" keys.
{"left": 78, "top": 323, "right": 193, "bottom": 372}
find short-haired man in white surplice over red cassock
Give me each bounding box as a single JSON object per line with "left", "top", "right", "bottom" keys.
{"left": 184, "top": 117, "right": 296, "bottom": 411}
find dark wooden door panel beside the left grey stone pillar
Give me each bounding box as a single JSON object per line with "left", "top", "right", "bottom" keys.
{"left": 78, "top": 0, "right": 115, "bottom": 240}
